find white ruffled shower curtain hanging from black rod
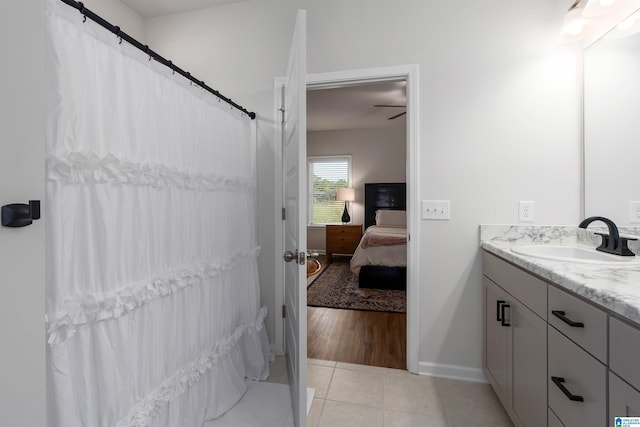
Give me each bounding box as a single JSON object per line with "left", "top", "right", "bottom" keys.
{"left": 45, "top": 0, "right": 271, "bottom": 427}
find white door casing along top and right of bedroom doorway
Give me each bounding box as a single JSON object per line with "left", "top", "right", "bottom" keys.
{"left": 307, "top": 65, "right": 420, "bottom": 373}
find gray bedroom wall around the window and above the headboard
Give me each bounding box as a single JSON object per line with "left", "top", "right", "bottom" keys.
{"left": 307, "top": 126, "right": 407, "bottom": 251}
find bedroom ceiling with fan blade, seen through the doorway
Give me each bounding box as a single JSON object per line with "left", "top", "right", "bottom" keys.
{"left": 307, "top": 81, "right": 407, "bottom": 131}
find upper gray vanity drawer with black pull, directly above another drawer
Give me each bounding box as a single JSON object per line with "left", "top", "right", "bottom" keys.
{"left": 547, "top": 286, "right": 607, "bottom": 364}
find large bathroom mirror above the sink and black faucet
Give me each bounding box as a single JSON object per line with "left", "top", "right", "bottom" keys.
{"left": 584, "top": 7, "right": 640, "bottom": 226}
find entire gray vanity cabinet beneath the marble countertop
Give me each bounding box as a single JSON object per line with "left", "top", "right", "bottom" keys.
{"left": 483, "top": 251, "right": 640, "bottom": 427}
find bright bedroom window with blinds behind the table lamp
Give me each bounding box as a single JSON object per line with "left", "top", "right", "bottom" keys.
{"left": 307, "top": 156, "right": 351, "bottom": 225}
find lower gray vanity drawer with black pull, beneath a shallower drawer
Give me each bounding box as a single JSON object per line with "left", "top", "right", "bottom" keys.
{"left": 547, "top": 327, "right": 608, "bottom": 427}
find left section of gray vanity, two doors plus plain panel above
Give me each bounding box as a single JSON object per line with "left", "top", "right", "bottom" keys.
{"left": 483, "top": 253, "right": 547, "bottom": 427}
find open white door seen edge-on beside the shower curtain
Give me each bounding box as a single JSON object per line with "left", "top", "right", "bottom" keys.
{"left": 282, "top": 10, "right": 307, "bottom": 427}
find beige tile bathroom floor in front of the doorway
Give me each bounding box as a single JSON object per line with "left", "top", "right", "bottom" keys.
{"left": 270, "top": 358, "right": 513, "bottom": 427}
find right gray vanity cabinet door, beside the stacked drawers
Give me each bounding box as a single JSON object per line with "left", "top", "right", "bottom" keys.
{"left": 509, "top": 301, "right": 547, "bottom": 427}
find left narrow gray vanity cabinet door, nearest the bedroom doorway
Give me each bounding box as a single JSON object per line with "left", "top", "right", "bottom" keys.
{"left": 483, "top": 277, "right": 509, "bottom": 408}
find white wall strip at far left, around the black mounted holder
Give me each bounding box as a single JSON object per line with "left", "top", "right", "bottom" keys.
{"left": 0, "top": 0, "right": 46, "bottom": 427}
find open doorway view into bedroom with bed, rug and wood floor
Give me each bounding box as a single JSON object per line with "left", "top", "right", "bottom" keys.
{"left": 307, "top": 79, "right": 407, "bottom": 369}
